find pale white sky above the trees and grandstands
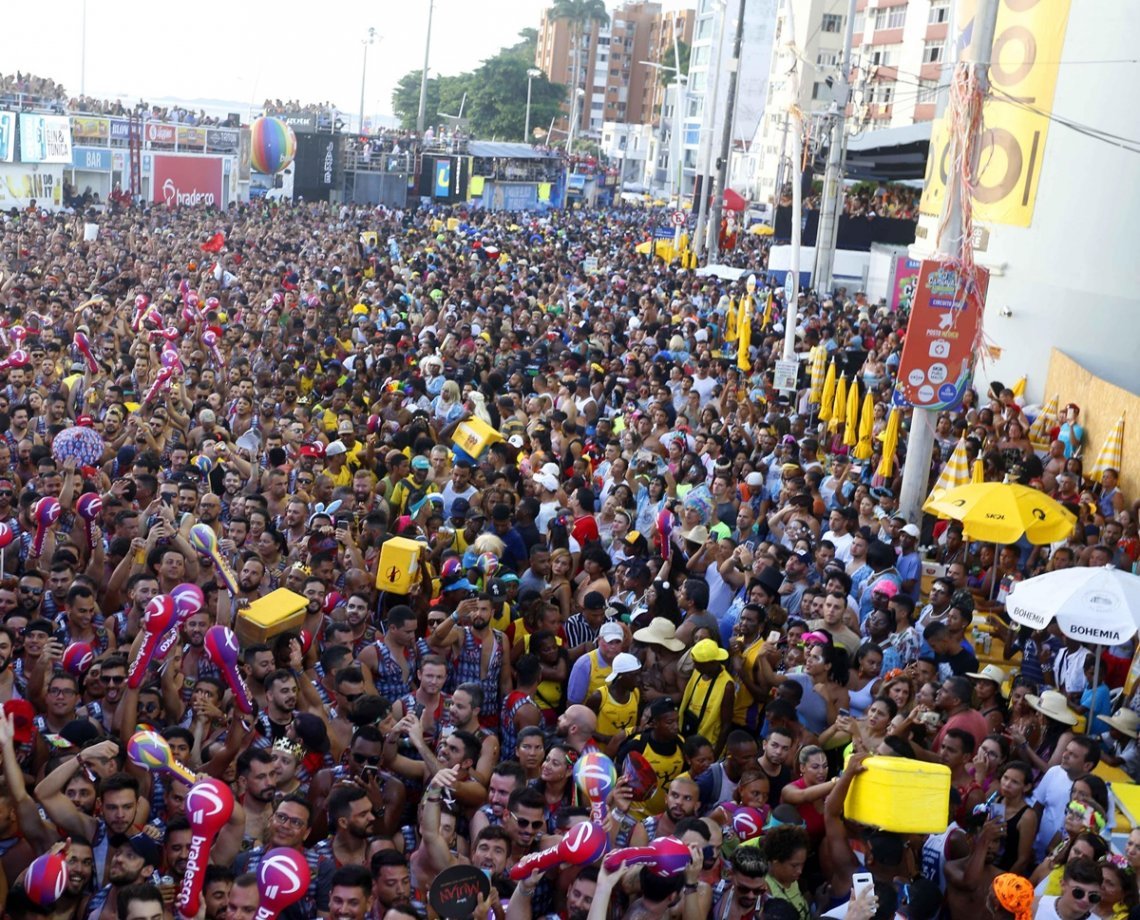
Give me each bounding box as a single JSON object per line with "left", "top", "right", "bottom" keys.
{"left": 0, "top": 0, "right": 678, "bottom": 119}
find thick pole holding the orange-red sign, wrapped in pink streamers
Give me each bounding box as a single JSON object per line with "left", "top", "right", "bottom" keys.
{"left": 898, "top": 0, "right": 999, "bottom": 522}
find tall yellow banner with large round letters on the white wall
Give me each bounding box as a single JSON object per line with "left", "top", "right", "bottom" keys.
{"left": 920, "top": 0, "right": 1070, "bottom": 227}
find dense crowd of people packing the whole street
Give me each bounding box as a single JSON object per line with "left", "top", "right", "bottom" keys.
{"left": 0, "top": 192, "right": 1140, "bottom": 920}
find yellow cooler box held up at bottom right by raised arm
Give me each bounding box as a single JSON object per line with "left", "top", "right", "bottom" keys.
{"left": 844, "top": 757, "right": 950, "bottom": 833}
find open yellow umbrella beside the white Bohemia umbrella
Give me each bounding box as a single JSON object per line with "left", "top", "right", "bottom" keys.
{"left": 922, "top": 482, "right": 1076, "bottom": 546}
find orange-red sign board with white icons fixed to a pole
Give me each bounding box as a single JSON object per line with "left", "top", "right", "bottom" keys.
{"left": 894, "top": 259, "right": 990, "bottom": 409}
